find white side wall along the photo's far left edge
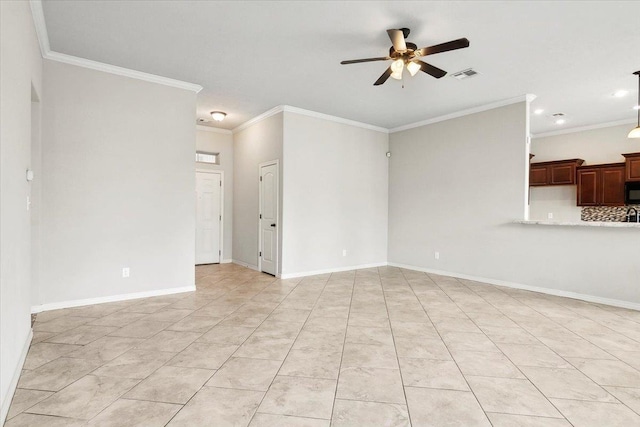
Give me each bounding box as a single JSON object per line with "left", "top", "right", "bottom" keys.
{"left": 0, "top": 1, "right": 42, "bottom": 424}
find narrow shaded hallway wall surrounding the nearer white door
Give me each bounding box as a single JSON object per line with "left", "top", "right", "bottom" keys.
{"left": 233, "top": 113, "right": 285, "bottom": 274}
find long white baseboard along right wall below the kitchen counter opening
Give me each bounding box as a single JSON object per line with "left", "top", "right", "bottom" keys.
{"left": 389, "top": 262, "right": 640, "bottom": 310}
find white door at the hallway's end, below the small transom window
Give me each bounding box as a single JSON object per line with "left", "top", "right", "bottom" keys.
{"left": 196, "top": 172, "right": 222, "bottom": 264}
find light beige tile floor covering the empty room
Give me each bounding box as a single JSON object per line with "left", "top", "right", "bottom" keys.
{"left": 6, "top": 264, "right": 640, "bottom": 427}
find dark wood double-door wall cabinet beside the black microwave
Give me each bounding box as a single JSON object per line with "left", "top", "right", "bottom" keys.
{"left": 576, "top": 163, "right": 625, "bottom": 206}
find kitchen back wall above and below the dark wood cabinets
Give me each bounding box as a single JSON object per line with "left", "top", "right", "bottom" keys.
{"left": 530, "top": 124, "right": 640, "bottom": 222}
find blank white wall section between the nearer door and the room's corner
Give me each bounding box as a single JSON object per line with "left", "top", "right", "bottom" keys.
{"left": 282, "top": 112, "right": 389, "bottom": 277}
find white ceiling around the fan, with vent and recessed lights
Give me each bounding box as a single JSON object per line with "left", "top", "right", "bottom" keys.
{"left": 44, "top": 0, "right": 640, "bottom": 133}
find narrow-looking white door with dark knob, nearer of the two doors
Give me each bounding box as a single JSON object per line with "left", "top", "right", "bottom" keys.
{"left": 260, "top": 163, "right": 278, "bottom": 276}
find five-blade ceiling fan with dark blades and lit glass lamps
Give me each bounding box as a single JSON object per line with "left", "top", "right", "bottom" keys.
{"left": 340, "top": 28, "right": 469, "bottom": 86}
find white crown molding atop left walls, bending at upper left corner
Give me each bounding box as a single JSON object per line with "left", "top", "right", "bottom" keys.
{"left": 29, "top": 0, "right": 202, "bottom": 93}
